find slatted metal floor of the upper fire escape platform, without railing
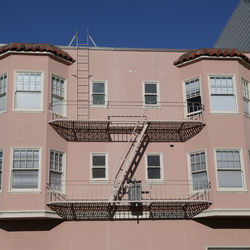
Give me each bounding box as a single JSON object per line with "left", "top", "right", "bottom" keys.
{"left": 49, "top": 119, "right": 205, "bottom": 142}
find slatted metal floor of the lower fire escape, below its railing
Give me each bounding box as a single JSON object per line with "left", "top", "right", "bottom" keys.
{"left": 47, "top": 200, "right": 211, "bottom": 221}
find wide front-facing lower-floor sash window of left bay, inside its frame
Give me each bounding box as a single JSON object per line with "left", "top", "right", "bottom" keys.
{"left": 11, "top": 149, "right": 39, "bottom": 189}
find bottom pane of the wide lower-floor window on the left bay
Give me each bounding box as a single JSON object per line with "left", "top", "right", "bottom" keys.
{"left": 12, "top": 170, "right": 38, "bottom": 188}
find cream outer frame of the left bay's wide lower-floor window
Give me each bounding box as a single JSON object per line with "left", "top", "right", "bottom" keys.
{"left": 9, "top": 146, "right": 42, "bottom": 193}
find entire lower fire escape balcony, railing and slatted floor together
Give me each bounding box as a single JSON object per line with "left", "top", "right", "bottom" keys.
{"left": 47, "top": 180, "right": 211, "bottom": 220}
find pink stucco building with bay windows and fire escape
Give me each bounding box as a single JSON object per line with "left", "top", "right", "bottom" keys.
{"left": 0, "top": 43, "right": 250, "bottom": 250}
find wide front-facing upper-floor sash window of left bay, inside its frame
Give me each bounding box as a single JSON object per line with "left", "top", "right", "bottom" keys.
{"left": 15, "top": 72, "right": 42, "bottom": 110}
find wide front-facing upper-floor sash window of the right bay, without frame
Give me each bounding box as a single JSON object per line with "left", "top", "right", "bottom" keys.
{"left": 210, "top": 76, "right": 236, "bottom": 112}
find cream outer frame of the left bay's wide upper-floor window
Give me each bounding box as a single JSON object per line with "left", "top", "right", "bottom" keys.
{"left": 12, "top": 70, "right": 44, "bottom": 113}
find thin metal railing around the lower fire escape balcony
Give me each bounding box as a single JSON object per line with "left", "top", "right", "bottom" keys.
{"left": 48, "top": 180, "right": 210, "bottom": 203}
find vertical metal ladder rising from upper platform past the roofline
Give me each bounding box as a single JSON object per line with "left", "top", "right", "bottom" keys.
{"left": 76, "top": 34, "right": 89, "bottom": 120}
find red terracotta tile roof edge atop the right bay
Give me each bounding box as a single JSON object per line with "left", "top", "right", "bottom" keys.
{"left": 174, "top": 48, "right": 250, "bottom": 65}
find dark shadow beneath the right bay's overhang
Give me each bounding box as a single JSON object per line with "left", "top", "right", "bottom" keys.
{"left": 193, "top": 217, "right": 250, "bottom": 229}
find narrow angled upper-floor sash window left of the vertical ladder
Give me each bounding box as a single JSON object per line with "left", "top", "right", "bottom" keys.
{"left": 51, "top": 76, "right": 65, "bottom": 115}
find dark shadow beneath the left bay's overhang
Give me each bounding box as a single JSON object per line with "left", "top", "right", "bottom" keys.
{"left": 0, "top": 219, "right": 63, "bottom": 232}
